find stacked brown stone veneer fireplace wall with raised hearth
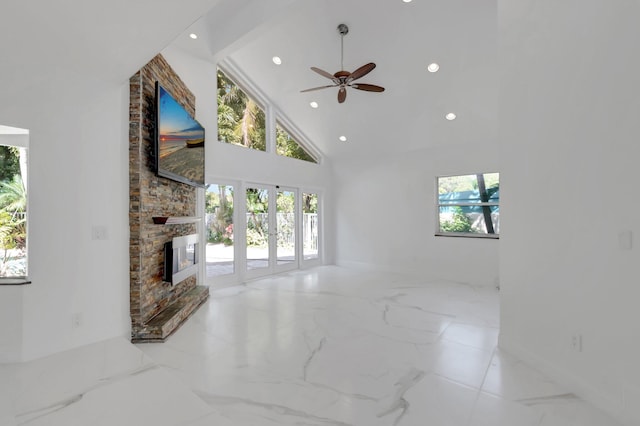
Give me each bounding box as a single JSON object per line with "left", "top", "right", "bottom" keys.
{"left": 129, "top": 55, "right": 209, "bottom": 342}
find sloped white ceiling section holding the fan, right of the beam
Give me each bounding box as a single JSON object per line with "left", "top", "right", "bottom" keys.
{"left": 171, "top": 0, "right": 498, "bottom": 158}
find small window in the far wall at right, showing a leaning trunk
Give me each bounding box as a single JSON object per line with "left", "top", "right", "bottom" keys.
{"left": 436, "top": 173, "right": 500, "bottom": 238}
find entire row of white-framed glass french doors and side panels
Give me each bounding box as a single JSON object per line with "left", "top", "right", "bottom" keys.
{"left": 202, "top": 181, "right": 321, "bottom": 287}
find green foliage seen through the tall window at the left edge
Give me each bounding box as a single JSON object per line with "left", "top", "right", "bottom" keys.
{"left": 0, "top": 146, "right": 27, "bottom": 277}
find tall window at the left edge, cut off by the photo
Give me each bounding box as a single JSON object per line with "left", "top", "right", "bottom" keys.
{"left": 0, "top": 126, "right": 29, "bottom": 284}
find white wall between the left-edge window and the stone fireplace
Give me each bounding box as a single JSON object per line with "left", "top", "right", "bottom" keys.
{"left": 0, "top": 81, "right": 129, "bottom": 361}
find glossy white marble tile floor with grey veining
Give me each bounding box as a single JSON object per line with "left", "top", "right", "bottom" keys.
{"left": 0, "top": 267, "right": 619, "bottom": 426}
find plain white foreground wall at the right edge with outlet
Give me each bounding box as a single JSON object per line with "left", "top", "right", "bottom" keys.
{"left": 499, "top": 0, "right": 640, "bottom": 425}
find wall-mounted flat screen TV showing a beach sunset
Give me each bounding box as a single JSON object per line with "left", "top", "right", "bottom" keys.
{"left": 155, "top": 82, "right": 204, "bottom": 186}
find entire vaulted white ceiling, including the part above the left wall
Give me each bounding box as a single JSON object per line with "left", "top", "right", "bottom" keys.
{"left": 0, "top": 0, "right": 498, "bottom": 159}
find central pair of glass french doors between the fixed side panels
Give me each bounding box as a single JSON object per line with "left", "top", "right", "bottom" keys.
{"left": 245, "top": 184, "right": 298, "bottom": 278}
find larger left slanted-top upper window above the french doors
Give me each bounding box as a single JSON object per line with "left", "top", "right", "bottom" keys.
{"left": 218, "top": 69, "right": 267, "bottom": 151}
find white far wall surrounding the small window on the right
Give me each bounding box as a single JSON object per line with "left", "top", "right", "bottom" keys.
{"left": 334, "top": 145, "right": 500, "bottom": 285}
